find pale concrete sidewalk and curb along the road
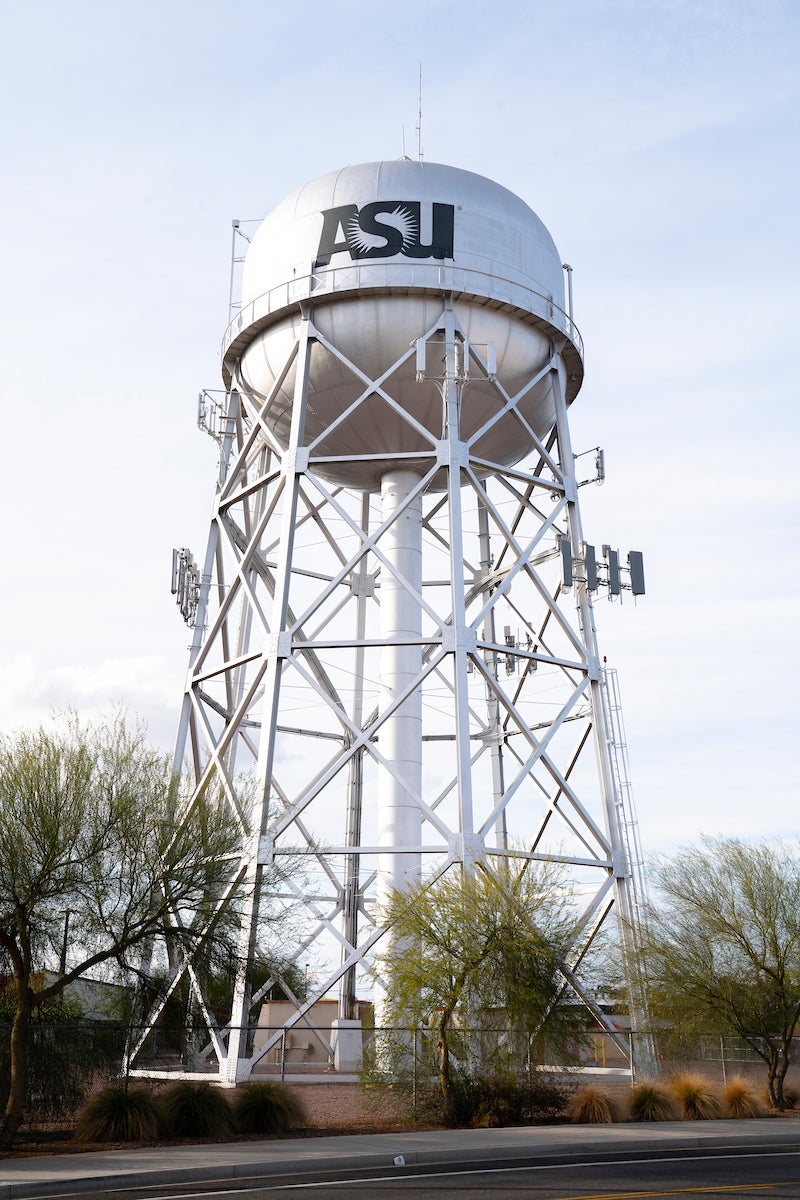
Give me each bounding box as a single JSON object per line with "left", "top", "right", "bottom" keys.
{"left": 0, "top": 1117, "right": 800, "bottom": 1200}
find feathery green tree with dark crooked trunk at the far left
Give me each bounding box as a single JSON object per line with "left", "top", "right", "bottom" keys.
{"left": 0, "top": 713, "right": 239, "bottom": 1146}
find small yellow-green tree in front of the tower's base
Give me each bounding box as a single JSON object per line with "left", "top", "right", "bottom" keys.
{"left": 378, "top": 862, "right": 576, "bottom": 1124}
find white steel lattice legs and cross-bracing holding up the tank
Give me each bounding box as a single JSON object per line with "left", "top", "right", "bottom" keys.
{"left": 126, "top": 295, "right": 652, "bottom": 1084}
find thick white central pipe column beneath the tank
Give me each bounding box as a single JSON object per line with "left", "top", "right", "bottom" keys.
{"left": 378, "top": 470, "right": 422, "bottom": 907}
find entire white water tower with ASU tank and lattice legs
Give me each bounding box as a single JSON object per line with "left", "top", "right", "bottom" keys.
{"left": 126, "top": 158, "right": 652, "bottom": 1084}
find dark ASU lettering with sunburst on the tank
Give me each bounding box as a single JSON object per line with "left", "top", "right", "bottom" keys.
{"left": 315, "top": 200, "right": 455, "bottom": 266}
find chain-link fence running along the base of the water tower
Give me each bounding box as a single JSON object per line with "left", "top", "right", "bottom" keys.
{"left": 0, "top": 1021, "right": 800, "bottom": 1114}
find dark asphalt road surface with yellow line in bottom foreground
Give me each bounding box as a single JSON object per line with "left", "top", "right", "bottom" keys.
{"left": 42, "top": 1150, "right": 800, "bottom": 1200}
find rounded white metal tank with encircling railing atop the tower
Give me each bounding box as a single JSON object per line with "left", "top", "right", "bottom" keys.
{"left": 223, "top": 158, "right": 583, "bottom": 491}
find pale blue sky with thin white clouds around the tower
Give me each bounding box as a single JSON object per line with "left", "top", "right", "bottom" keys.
{"left": 0, "top": 0, "right": 800, "bottom": 853}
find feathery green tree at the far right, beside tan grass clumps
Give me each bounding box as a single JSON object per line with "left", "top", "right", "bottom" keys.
{"left": 643, "top": 838, "right": 800, "bottom": 1110}
